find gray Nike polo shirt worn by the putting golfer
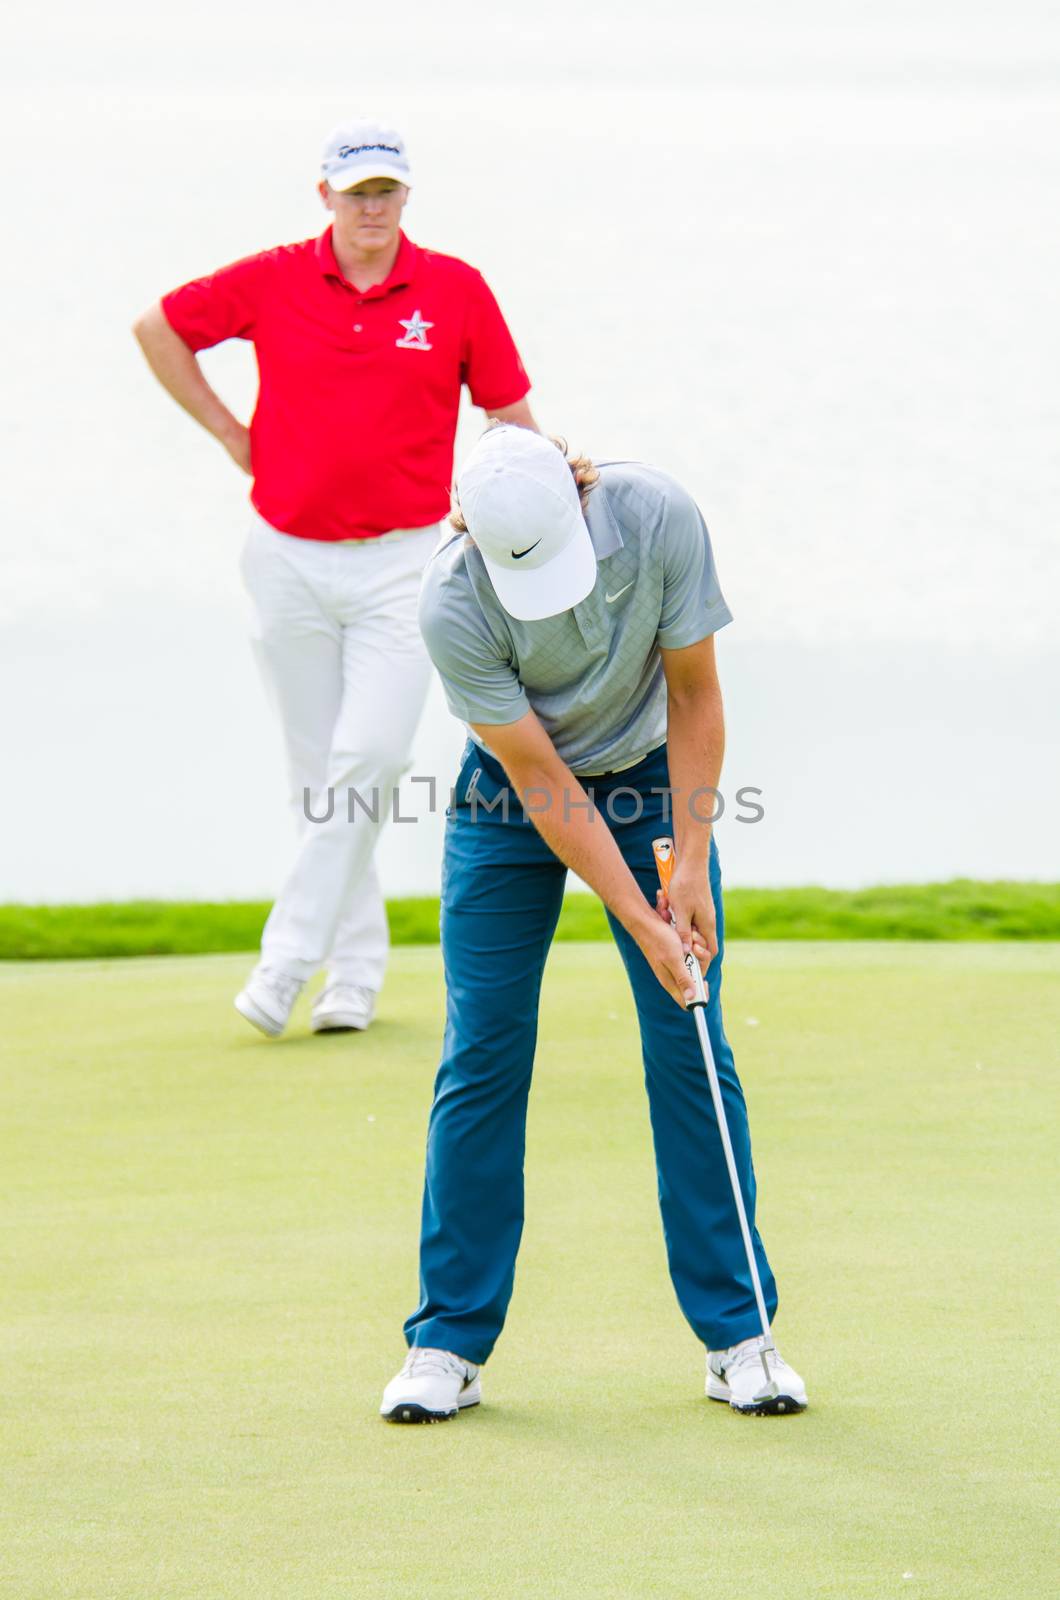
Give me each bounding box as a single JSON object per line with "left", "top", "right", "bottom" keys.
{"left": 420, "top": 461, "right": 732, "bottom": 773}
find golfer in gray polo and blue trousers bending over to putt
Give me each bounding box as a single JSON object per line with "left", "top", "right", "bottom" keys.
{"left": 381, "top": 424, "right": 805, "bottom": 1422}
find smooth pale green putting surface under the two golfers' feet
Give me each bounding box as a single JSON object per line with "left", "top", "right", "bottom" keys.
{"left": 0, "top": 942, "right": 1060, "bottom": 1600}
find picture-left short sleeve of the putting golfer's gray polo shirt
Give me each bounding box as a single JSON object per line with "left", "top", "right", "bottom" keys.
{"left": 420, "top": 547, "right": 530, "bottom": 725}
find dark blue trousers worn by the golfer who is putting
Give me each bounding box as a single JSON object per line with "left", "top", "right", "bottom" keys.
{"left": 405, "top": 746, "right": 777, "bottom": 1362}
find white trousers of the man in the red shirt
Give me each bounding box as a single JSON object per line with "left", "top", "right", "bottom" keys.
{"left": 242, "top": 517, "right": 439, "bottom": 990}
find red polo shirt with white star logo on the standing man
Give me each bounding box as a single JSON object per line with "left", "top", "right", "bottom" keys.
{"left": 162, "top": 229, "right": 530, "bottom": 539}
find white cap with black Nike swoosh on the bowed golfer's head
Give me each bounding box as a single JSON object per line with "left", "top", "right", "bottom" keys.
{"left": 456, "top": 422, "right": 596, "bottom": 622}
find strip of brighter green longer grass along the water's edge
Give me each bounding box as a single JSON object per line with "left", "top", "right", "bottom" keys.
{"left": 0, "top": 878, "right": 1060, "bottom": 962}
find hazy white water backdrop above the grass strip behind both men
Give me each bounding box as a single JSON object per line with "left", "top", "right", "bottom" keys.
{"left": 0, "top": 0, "right": 1060, "bottom": 899}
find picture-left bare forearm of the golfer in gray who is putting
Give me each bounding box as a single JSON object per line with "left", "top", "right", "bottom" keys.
{"left": 512, "top": 768, "right": 655, "bottom": 938}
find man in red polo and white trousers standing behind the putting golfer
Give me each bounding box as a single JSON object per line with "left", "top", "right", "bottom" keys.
{"left": 135, "top": 118, "right": 535, "bottom": 1035}
